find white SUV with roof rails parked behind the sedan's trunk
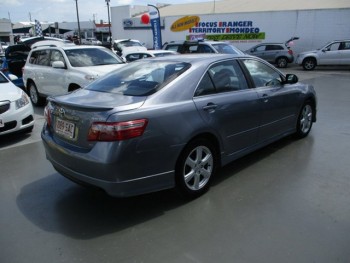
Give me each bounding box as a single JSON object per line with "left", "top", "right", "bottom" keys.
{"left": 23, "top": 41, "right": 125, "bottom": 105}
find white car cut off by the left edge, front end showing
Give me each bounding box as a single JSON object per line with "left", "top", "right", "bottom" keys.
{"left": 0, "top": 72, "right": 34, "bottom": 135}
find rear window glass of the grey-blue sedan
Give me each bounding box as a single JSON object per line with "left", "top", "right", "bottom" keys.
{"left": 86, "top": 60, "right": 191, "bottom": 96}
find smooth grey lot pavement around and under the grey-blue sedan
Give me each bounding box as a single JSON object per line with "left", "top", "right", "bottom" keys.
{"left": 0, "top": 67, "right": 350, "bottom": 263}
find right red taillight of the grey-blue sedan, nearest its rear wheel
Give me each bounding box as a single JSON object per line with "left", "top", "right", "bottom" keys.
{"left": 88, "top": 119, "right": 148, "bottom": 141}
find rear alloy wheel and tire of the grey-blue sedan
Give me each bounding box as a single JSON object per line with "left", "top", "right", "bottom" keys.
{"left": 175, "top": 139, "right": 218, "bottom": 198}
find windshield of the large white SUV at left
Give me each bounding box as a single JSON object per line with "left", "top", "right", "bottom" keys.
{"left": 65, "top": 48, "right": 123, "bottom": 67}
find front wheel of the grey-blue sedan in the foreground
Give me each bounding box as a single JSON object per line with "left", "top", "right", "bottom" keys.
{"left": 295, "top": 101, "right": 314, "bottom": 138}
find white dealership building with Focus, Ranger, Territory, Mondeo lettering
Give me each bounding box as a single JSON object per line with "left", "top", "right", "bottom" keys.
{"left": 111, "top": 0, "right": 350, "bottom": 53}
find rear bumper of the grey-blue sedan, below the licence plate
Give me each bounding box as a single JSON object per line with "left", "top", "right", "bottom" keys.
{"left": 41, "top": 131, "right": 175, "bottom": 197}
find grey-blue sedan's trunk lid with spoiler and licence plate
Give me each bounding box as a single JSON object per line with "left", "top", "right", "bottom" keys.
{"left": 45, "top": 89, "right": 145, "bottom": 151}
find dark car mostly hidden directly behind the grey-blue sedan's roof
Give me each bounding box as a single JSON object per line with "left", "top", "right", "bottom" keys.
{"left": 163, "top": 40, "right": 244, "bottom": 55}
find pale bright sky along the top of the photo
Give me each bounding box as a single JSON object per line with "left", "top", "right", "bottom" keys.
{"left": 0, "top": 0, "right": 214, "bottom": 23}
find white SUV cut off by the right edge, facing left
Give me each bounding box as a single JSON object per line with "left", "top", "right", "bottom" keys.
{"left": 296, "top": 39, "right": 350, "bottom": 70}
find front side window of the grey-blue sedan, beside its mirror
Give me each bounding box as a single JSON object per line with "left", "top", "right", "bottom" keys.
{"left": 243, "top": 59, "right": 282, "bottom": 87}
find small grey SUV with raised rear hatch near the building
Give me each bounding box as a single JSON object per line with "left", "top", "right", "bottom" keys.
{"left": 244, "top": 37, "right": 299, "bottom": 68}
